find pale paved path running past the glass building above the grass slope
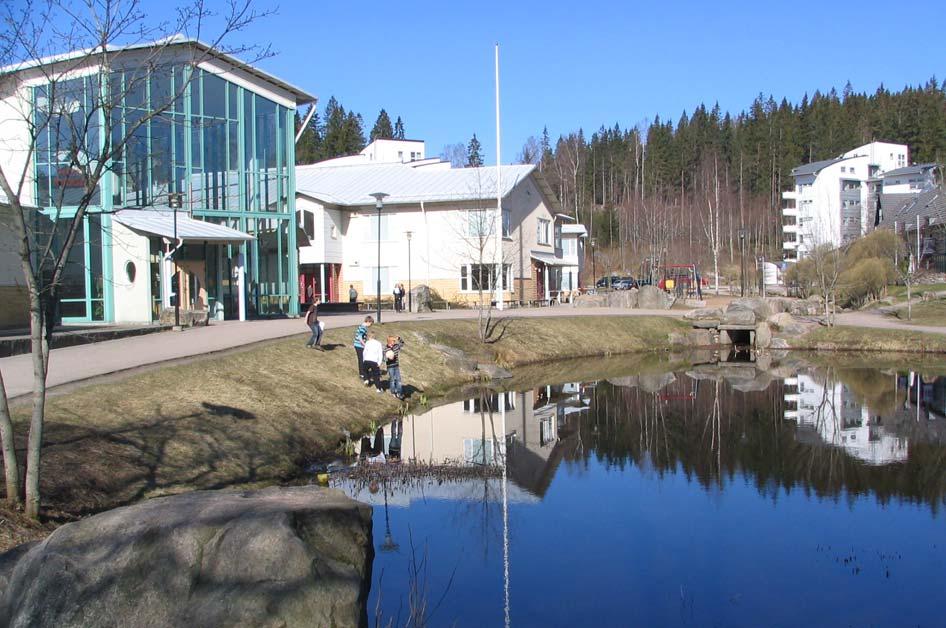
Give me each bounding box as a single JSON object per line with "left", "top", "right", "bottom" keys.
{"left": 0, "top": 306, "right": 685, "bottom": 399}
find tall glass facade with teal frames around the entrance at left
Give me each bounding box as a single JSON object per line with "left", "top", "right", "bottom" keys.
{"left": 31, "top": 59, "right": 299, "bottom": 322}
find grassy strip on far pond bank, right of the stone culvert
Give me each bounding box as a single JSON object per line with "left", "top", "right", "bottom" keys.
{"left": 789, "top": 326, "right": 946, "bottom": 353}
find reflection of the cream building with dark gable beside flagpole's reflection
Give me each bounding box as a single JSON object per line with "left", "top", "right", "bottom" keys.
{"left": 348, "top": 383, "right": 590, "bottom": 498}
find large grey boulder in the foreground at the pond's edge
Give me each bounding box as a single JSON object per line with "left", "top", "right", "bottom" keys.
{"left": 0, "top": 487, "right": 373, "bottom": 628}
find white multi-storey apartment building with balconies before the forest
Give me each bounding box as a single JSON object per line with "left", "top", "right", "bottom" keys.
{"left": 782, "top": 142, "right": 909, "bottom": 262}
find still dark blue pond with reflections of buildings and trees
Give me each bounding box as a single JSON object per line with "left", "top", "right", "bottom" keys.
{"left": 330, "top": 362, "right": 946, "bottom": 626}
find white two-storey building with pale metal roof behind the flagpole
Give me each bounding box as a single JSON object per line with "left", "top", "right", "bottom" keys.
{"left": 296, "top": 140, "right": 585, "bottom": 310}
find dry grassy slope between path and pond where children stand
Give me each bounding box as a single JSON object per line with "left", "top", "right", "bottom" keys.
{"left": 0, "top": 316, "right": 684, "bottom": 548}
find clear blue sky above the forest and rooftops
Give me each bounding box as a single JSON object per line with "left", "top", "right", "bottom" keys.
{"left": 218, "top": 0, "right": 946, "bottom": 163}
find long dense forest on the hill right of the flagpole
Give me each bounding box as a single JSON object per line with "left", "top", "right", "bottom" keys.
{"left": 519, "top": 78, "right": 946, "bottom": 278}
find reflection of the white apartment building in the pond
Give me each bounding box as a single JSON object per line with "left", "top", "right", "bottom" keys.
{"left": 784, "top": 373, "right": 908, "bottom": 465}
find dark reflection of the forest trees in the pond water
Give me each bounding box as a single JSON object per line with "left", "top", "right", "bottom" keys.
{"left": 566, "top": 370, "right": 946, "bottom": 512}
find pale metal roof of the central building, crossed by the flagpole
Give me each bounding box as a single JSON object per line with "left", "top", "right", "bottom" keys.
{"left": 296, "top": 162, "right": 545, "bottom": 207}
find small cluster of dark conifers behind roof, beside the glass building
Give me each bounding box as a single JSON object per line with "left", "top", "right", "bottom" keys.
{"left": 296, "top": 96, "right": 405, "bottom": 165}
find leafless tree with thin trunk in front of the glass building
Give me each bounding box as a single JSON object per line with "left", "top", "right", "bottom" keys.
{"left": 0, "top": 0, "right": 269, "bottom": 518}
